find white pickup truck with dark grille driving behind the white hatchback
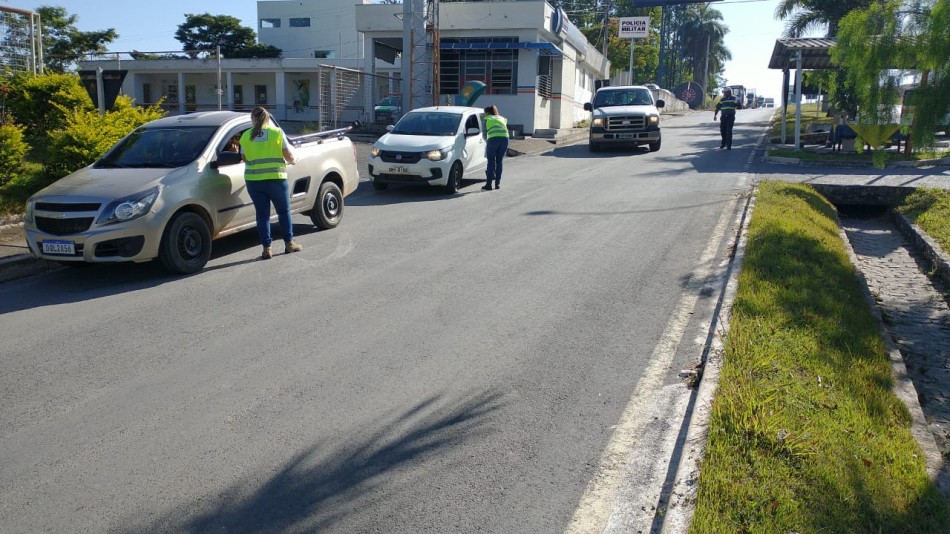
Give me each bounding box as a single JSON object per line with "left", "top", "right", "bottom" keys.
{"left": 584, "top": 85, "right": 666, "bottom": 152}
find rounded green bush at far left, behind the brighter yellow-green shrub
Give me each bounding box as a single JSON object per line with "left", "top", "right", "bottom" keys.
{"left": 6, "top": 74, "right": 95, "bottom": 139}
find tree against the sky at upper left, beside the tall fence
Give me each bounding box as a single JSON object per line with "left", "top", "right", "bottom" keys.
{"left": 36, "top": 6, "right": 119, "bottom": 73}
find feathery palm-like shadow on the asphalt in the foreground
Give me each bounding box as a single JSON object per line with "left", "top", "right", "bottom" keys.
{"left": 125, "top": 391, "right": 504, "bottom": 533}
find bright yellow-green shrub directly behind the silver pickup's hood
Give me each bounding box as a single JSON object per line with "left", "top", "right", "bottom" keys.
{"left": 46, "top": 95, "right": 165, "bottom": 178}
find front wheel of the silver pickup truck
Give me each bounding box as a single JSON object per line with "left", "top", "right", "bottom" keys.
{"left": 158, "top": 211, "right": 211, "bottom": 274}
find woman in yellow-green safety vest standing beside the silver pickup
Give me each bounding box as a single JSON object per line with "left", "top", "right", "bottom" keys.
{"left": 240, "top": 106, "right": 303, "bottom": 260}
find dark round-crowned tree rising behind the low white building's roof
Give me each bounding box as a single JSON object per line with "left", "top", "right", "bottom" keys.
{"left": 175, "top": 13, "right": 255, "bottom": 58}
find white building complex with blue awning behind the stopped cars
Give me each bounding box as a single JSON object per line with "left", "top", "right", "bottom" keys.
{"left": 80, "top": 0, "right": 609, "bottom": 134}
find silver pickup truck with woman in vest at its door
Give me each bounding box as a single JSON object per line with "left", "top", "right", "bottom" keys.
{"left": 24, "top": 111, "right": 359, "bottom": 274}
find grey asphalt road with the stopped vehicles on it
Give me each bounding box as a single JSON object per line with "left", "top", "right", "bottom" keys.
{"left": 0, "top": 110, "right": 768, "bottom": 533}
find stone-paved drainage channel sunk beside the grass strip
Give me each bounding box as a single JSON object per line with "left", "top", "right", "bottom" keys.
{"left": 832, "top": 186, "right": 950, "bottom": 496}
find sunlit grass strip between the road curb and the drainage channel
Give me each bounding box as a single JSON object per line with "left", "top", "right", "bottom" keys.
{"left": 691, "top": 182, "right": 950, "bottom": 533}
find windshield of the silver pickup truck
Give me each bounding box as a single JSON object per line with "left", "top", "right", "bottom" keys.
{"left": 93, "top": 126, "right": 217, "bottom": 169}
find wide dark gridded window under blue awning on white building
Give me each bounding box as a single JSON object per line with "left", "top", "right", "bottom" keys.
{"left": 439, "top": 37, "right": 518, "bottom": 95}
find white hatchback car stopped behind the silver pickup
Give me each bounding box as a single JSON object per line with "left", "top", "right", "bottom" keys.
{"left": 369, "top": 106, "right": 487, "bottom": 193}
